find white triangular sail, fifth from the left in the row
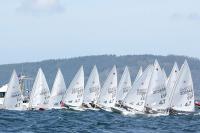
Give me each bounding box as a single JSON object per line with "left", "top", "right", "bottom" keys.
{"left": 83, "top": 66, "right": 101, "bottom": 104}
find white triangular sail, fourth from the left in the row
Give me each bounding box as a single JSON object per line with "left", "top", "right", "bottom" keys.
{"left": 62, "top": 66, "right": 84, "bottom": 107}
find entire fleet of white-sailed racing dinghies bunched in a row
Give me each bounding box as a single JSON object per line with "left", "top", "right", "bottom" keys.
{"left": 1, "top": 60, "right": 195, "bottom": 115}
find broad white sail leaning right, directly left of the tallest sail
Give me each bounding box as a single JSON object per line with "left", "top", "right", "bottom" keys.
{"left": 123, "top": 65, "right": 154, "bottom": 112}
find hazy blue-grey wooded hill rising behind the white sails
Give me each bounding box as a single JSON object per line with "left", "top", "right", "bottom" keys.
{"left": 0, "top": 55, "right": 200, "bottom": 98}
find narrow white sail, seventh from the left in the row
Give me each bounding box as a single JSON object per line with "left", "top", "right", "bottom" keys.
{"left": 116, "top": 66, "right": 132, "bottom": 102}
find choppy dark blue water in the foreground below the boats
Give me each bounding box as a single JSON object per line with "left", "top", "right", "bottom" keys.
{"left": 0, "top": 110, "right": 200, "bottom": 133}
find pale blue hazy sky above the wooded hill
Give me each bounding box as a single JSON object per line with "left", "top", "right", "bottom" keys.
{"left": 0, "top": 0, "right": 200, "bottom": 64}
